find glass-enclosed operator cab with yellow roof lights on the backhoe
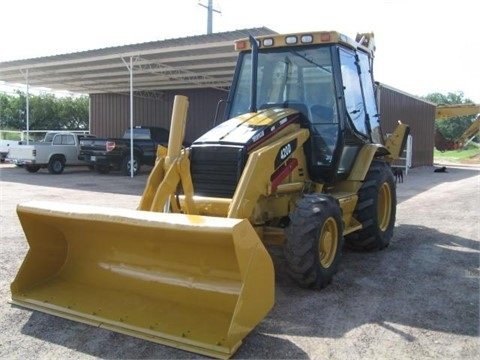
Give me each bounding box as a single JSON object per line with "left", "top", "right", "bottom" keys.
{"left": 225, "top": 33, "right": 381, "bottom": 183}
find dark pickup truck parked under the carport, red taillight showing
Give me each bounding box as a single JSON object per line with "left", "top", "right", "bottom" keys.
{"left": 78, "top": 126, "right": 169, "bottom": 175}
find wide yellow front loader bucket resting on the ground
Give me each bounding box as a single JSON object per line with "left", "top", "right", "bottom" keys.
{"left": 11, "top": 201, "right": 274, "bottom": 358}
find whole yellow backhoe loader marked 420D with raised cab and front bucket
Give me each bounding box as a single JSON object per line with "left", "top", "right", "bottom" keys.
{"left": 11, "top": 32, "right": 408, "bottom": 358}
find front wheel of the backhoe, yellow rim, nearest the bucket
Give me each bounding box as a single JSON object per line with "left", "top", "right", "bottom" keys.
{"left": 284, "top": 194, "right": 344, "bottom": 289}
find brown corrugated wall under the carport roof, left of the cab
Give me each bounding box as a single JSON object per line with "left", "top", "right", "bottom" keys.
{"left": 90, "top": 89, "right": 227, "bottom": 142}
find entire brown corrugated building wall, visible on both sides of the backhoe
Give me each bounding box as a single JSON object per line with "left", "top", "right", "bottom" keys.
{"left": 90, "top": 85, "right": 435, "bottom": 167}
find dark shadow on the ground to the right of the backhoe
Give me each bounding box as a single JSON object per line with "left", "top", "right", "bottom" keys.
{"left": 260, "top": 225, "right": 480, "bottom": 339}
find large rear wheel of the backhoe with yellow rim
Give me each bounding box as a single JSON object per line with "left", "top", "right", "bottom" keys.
{"left": 345, "top": 160, "right": 397, "bottom": 251}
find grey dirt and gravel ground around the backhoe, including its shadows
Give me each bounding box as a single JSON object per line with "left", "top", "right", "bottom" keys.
{"left": 0, "top": 164, "right": 480, "bottom": 360}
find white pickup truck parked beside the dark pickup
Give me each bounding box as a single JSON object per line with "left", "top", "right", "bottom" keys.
{"left": 6, "top": 131, "right": 95, "bottom": 174}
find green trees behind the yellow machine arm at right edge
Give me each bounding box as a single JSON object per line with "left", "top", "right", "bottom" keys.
{"left": 424, "top": 91, "right": 475, "bottom": 141}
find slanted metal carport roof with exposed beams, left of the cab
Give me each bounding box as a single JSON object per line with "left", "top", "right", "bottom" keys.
{"left": 0, "top": 27, "right": 276, "bottom": 94}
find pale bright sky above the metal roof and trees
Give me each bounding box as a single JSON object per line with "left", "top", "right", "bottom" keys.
{"left": 0, "top": 0, "right": 480, "bottom": 103}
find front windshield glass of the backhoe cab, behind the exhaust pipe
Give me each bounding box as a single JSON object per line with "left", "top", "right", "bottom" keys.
{"left": 230, "top": 47, "right": 336, "bottom": 122}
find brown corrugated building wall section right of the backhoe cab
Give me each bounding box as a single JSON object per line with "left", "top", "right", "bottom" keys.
{"left": 377, "top": 85, "right": 435, "bottom": 167}
